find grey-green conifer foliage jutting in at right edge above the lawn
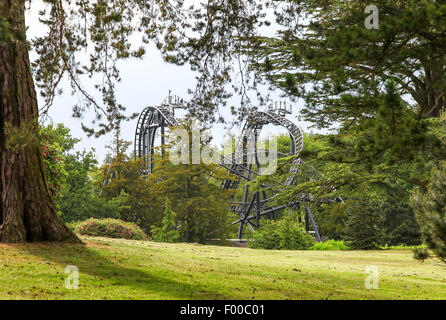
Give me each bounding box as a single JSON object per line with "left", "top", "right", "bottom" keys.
{"left": 412, "top": 161, "right": 446, "bottom": 262}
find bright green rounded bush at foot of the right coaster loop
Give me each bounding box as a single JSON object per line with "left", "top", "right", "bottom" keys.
{"left": 248, "top": 215, "right": 314, "bottom": 250}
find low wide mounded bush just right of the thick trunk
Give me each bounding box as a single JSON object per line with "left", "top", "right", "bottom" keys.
{"left": 71, "top": 218, "right": 148, "bottom": 240}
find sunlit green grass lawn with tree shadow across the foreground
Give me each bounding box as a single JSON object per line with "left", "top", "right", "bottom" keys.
{"left": 0, "top": 238, "right": 446, "bottom": 299}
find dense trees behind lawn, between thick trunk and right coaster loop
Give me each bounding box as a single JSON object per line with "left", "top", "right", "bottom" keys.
{"left": 42, "top": 125, "right": 231, "bottom": 243}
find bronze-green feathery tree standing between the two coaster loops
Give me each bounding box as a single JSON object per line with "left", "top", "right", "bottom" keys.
{"left": 145, "top": 159, "right": 230, "bottom": 243}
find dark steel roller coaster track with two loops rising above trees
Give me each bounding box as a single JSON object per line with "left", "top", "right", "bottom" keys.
{"left": 134, "top": 93, "right": 322, "bottom": 241}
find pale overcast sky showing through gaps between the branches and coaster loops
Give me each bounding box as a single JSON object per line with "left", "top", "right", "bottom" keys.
{"left": 27, "top": 1, "right": 318, "bottom": 161}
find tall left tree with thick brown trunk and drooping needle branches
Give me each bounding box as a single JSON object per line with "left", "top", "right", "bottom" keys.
{"left": 0, "top": 0, "right": 251, "bottom": 242}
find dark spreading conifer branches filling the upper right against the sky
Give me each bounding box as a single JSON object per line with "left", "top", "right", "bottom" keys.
{"left": 160, "top": 0, "right": 446, "bottom": 127}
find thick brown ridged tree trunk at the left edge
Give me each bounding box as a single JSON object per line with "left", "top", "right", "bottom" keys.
{"left": 0, "top": 0, "right": 80, "bottom": 242}
